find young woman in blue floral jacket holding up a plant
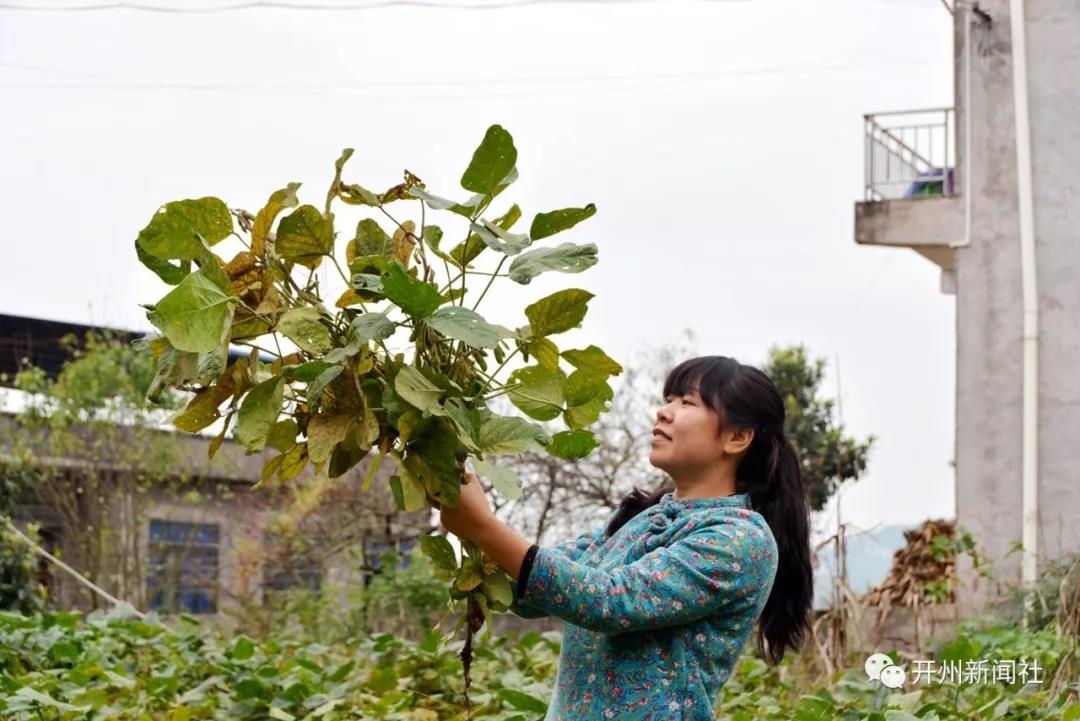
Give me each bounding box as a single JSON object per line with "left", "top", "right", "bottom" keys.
{"left": 441, "top": 356, "right": 812, "bottom": 721}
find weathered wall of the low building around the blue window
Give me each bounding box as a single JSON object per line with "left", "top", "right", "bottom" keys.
{"left": 0, "top": 405, "right": 433, "bottom": 621}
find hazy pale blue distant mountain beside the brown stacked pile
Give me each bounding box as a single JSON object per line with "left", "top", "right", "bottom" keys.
{"left": 813, "top": 525, "right": 914, "bottom": 609}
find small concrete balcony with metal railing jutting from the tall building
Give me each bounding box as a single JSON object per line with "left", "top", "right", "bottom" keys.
{"left": 855, "top": 108, "right": 963, "bottom": 293}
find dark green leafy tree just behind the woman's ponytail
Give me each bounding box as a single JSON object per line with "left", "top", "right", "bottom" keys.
{"left": 761, "top": 344, "right": 875, "bottom": 511}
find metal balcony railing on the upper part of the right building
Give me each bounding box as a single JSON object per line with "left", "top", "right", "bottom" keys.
{"left": 863, "top": 108, "right": 957, "bottom": 201}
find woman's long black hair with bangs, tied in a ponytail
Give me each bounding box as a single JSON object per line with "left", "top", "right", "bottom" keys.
{"left": 607, "top": 355, "right": 813, "bottom": 664}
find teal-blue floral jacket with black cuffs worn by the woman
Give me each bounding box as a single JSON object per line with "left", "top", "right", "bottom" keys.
{"left": 511, "top": 492, "right": 778, "bottom": 721}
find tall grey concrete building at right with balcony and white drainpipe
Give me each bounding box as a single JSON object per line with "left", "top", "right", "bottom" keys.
{"left": 854, "top": 0, "right": 1080, "bottom": 610}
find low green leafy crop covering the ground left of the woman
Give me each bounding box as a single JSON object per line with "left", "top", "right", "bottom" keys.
{"left": 0, "top": 609, "right": 559, "bottom": 721}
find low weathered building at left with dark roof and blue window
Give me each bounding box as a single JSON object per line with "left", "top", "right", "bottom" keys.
{"left": 0, "top": 315, "right": 434, "bottom": 623}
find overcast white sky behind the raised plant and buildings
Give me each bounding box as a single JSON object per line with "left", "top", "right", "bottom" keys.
{"left": 0, "top": 0, "right": 955, "bottom": 527}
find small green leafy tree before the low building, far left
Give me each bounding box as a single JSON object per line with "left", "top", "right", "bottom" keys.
{"left": 0, "top": 332, "right": 187, "bottom": 609}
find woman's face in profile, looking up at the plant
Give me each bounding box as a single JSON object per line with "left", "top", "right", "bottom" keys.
{"left": 649, "top": 389, "right": 724, "bottom": 476}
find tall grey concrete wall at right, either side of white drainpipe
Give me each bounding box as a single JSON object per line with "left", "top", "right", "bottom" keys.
{"left": 956, "top": 0, "right": 1080, "bottom": 604}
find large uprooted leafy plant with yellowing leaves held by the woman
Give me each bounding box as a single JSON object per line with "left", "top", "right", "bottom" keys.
{"left": 135, "top": 125, "right": 622, "bottom": 704}
